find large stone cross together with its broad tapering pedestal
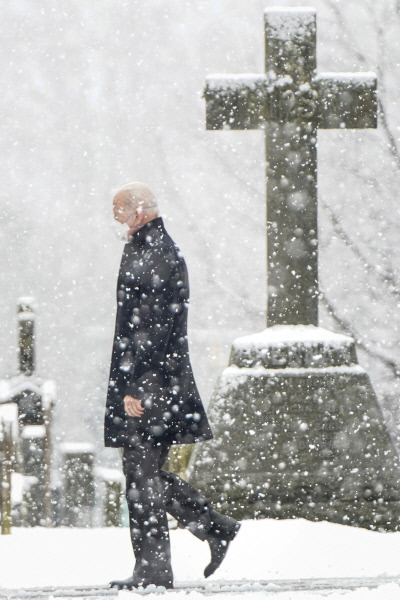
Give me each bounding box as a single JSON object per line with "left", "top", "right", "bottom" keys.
{"left": 187, "top": 8, "right": 400, "bottom": 530}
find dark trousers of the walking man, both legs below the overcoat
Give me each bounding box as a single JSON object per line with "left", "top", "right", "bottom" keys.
{"left": 122, "top": 441, "right": 237, "bottom": 580}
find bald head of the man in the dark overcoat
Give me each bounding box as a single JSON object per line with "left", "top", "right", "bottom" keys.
{"left": 113, "top": 181, "right": 158, "bottom": 230}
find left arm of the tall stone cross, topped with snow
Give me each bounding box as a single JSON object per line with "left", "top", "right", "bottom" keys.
{"left": 203, "top": 74, "right": 268, "bottom": 129}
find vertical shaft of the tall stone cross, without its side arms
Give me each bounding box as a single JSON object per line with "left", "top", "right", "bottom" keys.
{"left": 265, "top": 11, "right": 318, "bottom": 326}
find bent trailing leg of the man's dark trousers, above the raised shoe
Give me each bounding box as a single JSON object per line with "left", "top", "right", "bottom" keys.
{"left": 159, "top": 444, "right": 240, "bottom": 541}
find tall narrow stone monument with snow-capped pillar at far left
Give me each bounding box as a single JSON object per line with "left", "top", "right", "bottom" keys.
{"left": 0, "top": 296, "right": 56, "bottom": 526}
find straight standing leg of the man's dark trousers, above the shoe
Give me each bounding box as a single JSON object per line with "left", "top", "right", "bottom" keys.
{"left": 122, "top": 442, "right": 173, "bottom": 584}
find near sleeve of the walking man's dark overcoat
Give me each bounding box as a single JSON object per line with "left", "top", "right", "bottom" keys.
{"left": 125, "top": 255, "right": 186, "bottom": 398}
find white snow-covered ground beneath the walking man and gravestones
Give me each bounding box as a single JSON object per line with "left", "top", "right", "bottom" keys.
{"left": 0, "top": 519, "right": 400, "bottom": 600}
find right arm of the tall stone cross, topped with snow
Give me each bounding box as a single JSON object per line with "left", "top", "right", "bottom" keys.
{"left": 313, "top": 73, "right": 377, "bottom": 129}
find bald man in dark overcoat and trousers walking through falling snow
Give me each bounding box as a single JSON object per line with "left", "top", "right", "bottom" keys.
{"left": 104, "top": 182, "right": 240, "bottom": 589}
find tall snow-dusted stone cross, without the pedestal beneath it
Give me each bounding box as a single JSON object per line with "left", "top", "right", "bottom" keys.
{"left": 204, "top": 8, "right": 377, "bottom": 326}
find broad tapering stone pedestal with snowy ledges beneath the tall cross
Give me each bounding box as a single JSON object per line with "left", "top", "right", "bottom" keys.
{"left": 187, "top": 325, "right": 400, "bottom": 531}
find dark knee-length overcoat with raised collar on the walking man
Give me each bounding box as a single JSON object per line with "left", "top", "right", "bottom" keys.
{"left": 104, "top": 217, "right": 213, "bottom": 447}
